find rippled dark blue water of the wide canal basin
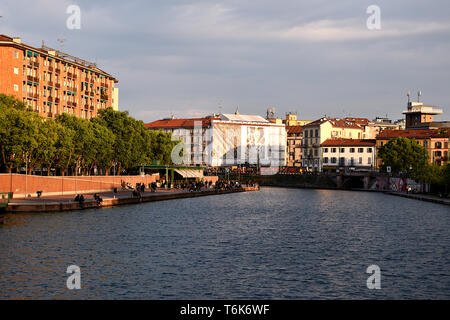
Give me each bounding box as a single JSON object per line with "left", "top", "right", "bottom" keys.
{"left": 0, "top": 188, "right": 450, "bottom": 299}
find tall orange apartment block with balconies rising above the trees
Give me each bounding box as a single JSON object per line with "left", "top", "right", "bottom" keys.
{"left": 0, "top": 35, "right": 118, "bottom": 119}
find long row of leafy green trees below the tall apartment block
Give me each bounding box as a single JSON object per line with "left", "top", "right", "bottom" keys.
{"left": 0, "top": 94, "right": 176, "bottom": 175}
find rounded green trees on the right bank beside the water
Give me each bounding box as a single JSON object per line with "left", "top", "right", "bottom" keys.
{"left": 378, "top": 137, "right": 450, "bottom": 192}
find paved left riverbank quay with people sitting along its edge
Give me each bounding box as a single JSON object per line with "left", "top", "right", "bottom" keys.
{"left": 4, "top": 187, "right": 259, "bottom": 213}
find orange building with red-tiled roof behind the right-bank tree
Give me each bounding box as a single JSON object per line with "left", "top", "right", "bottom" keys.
{"left": 377, "top": 129, "right": 450, "bottom": 168}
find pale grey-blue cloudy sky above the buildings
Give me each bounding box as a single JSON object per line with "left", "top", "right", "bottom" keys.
{"left": 0, "top": 0, "right": 450, "bottom": 122}
